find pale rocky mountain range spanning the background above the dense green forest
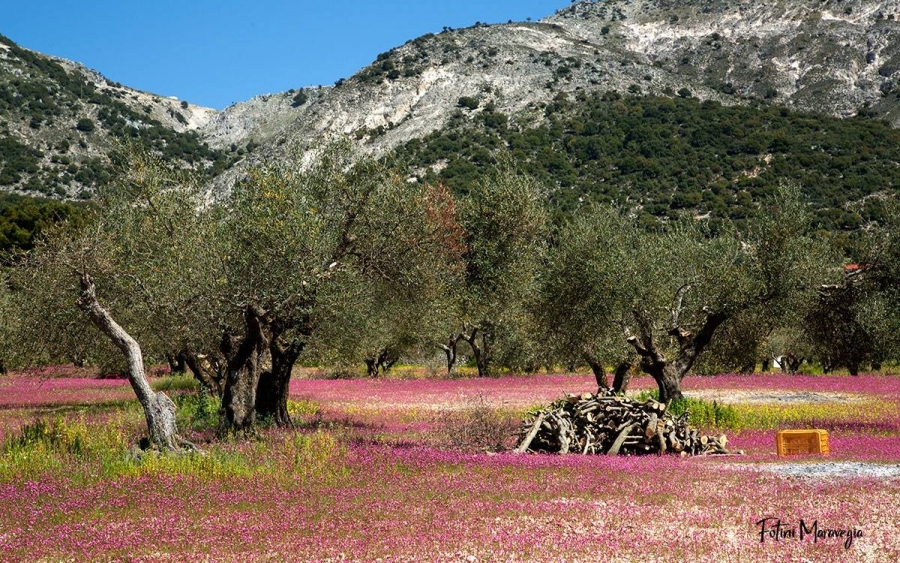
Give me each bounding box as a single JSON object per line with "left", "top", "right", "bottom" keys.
{"left": 0, "top": 0, "right": 900, "bottom": 203}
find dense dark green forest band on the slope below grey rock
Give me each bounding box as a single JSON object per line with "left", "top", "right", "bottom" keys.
{"left": 398, "top": 91, "right": 900, "bottom": 230}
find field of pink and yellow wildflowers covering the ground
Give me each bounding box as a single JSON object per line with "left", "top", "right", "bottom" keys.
{"left": 0, "top": 373, "right": 900, "bottom": 562}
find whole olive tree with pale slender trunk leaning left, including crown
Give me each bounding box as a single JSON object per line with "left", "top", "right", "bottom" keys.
{"left": 13, "top": 149, "right": 209, "bottom": 450}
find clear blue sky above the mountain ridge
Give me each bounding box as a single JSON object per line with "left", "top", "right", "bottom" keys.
{"left": 0, "top": 0, "right": 570, "bottom": 109}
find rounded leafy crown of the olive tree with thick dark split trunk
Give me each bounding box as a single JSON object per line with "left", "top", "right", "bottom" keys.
{"left": 217, "top": 144, "right": 462, "bottom": 372}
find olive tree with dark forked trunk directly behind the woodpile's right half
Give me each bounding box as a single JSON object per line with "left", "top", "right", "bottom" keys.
{"left": 627, "top": 187, "right": 829, "bottom": 402}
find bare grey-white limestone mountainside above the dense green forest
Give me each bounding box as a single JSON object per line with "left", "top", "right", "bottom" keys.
{"left": 213, "top": 0, "right": 900, "bottom": 186}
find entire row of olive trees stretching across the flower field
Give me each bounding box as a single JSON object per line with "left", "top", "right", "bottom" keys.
{"left": 0, "top": 143, "right": 900, "bottom": 458}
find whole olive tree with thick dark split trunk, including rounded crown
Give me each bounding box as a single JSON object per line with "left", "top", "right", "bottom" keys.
{"left": 216, "top": 145, "right": 460, "bottom": 431}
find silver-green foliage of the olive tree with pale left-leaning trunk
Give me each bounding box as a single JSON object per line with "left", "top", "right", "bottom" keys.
{"left": 12, "top": 147, "right": 211, "bottom": 368}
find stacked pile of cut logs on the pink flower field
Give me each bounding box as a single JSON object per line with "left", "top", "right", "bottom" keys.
{"left": 515, "top": 393, "right": 743, "bottom": 456}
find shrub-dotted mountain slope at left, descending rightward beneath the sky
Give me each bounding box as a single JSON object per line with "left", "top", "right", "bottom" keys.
{"left": 0, "top": 36, "right": 229, "bottom": 198}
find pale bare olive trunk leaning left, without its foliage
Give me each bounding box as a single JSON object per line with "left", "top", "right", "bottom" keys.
{"left": 78, "top": 274, "right": 189, "bottom": 451}
